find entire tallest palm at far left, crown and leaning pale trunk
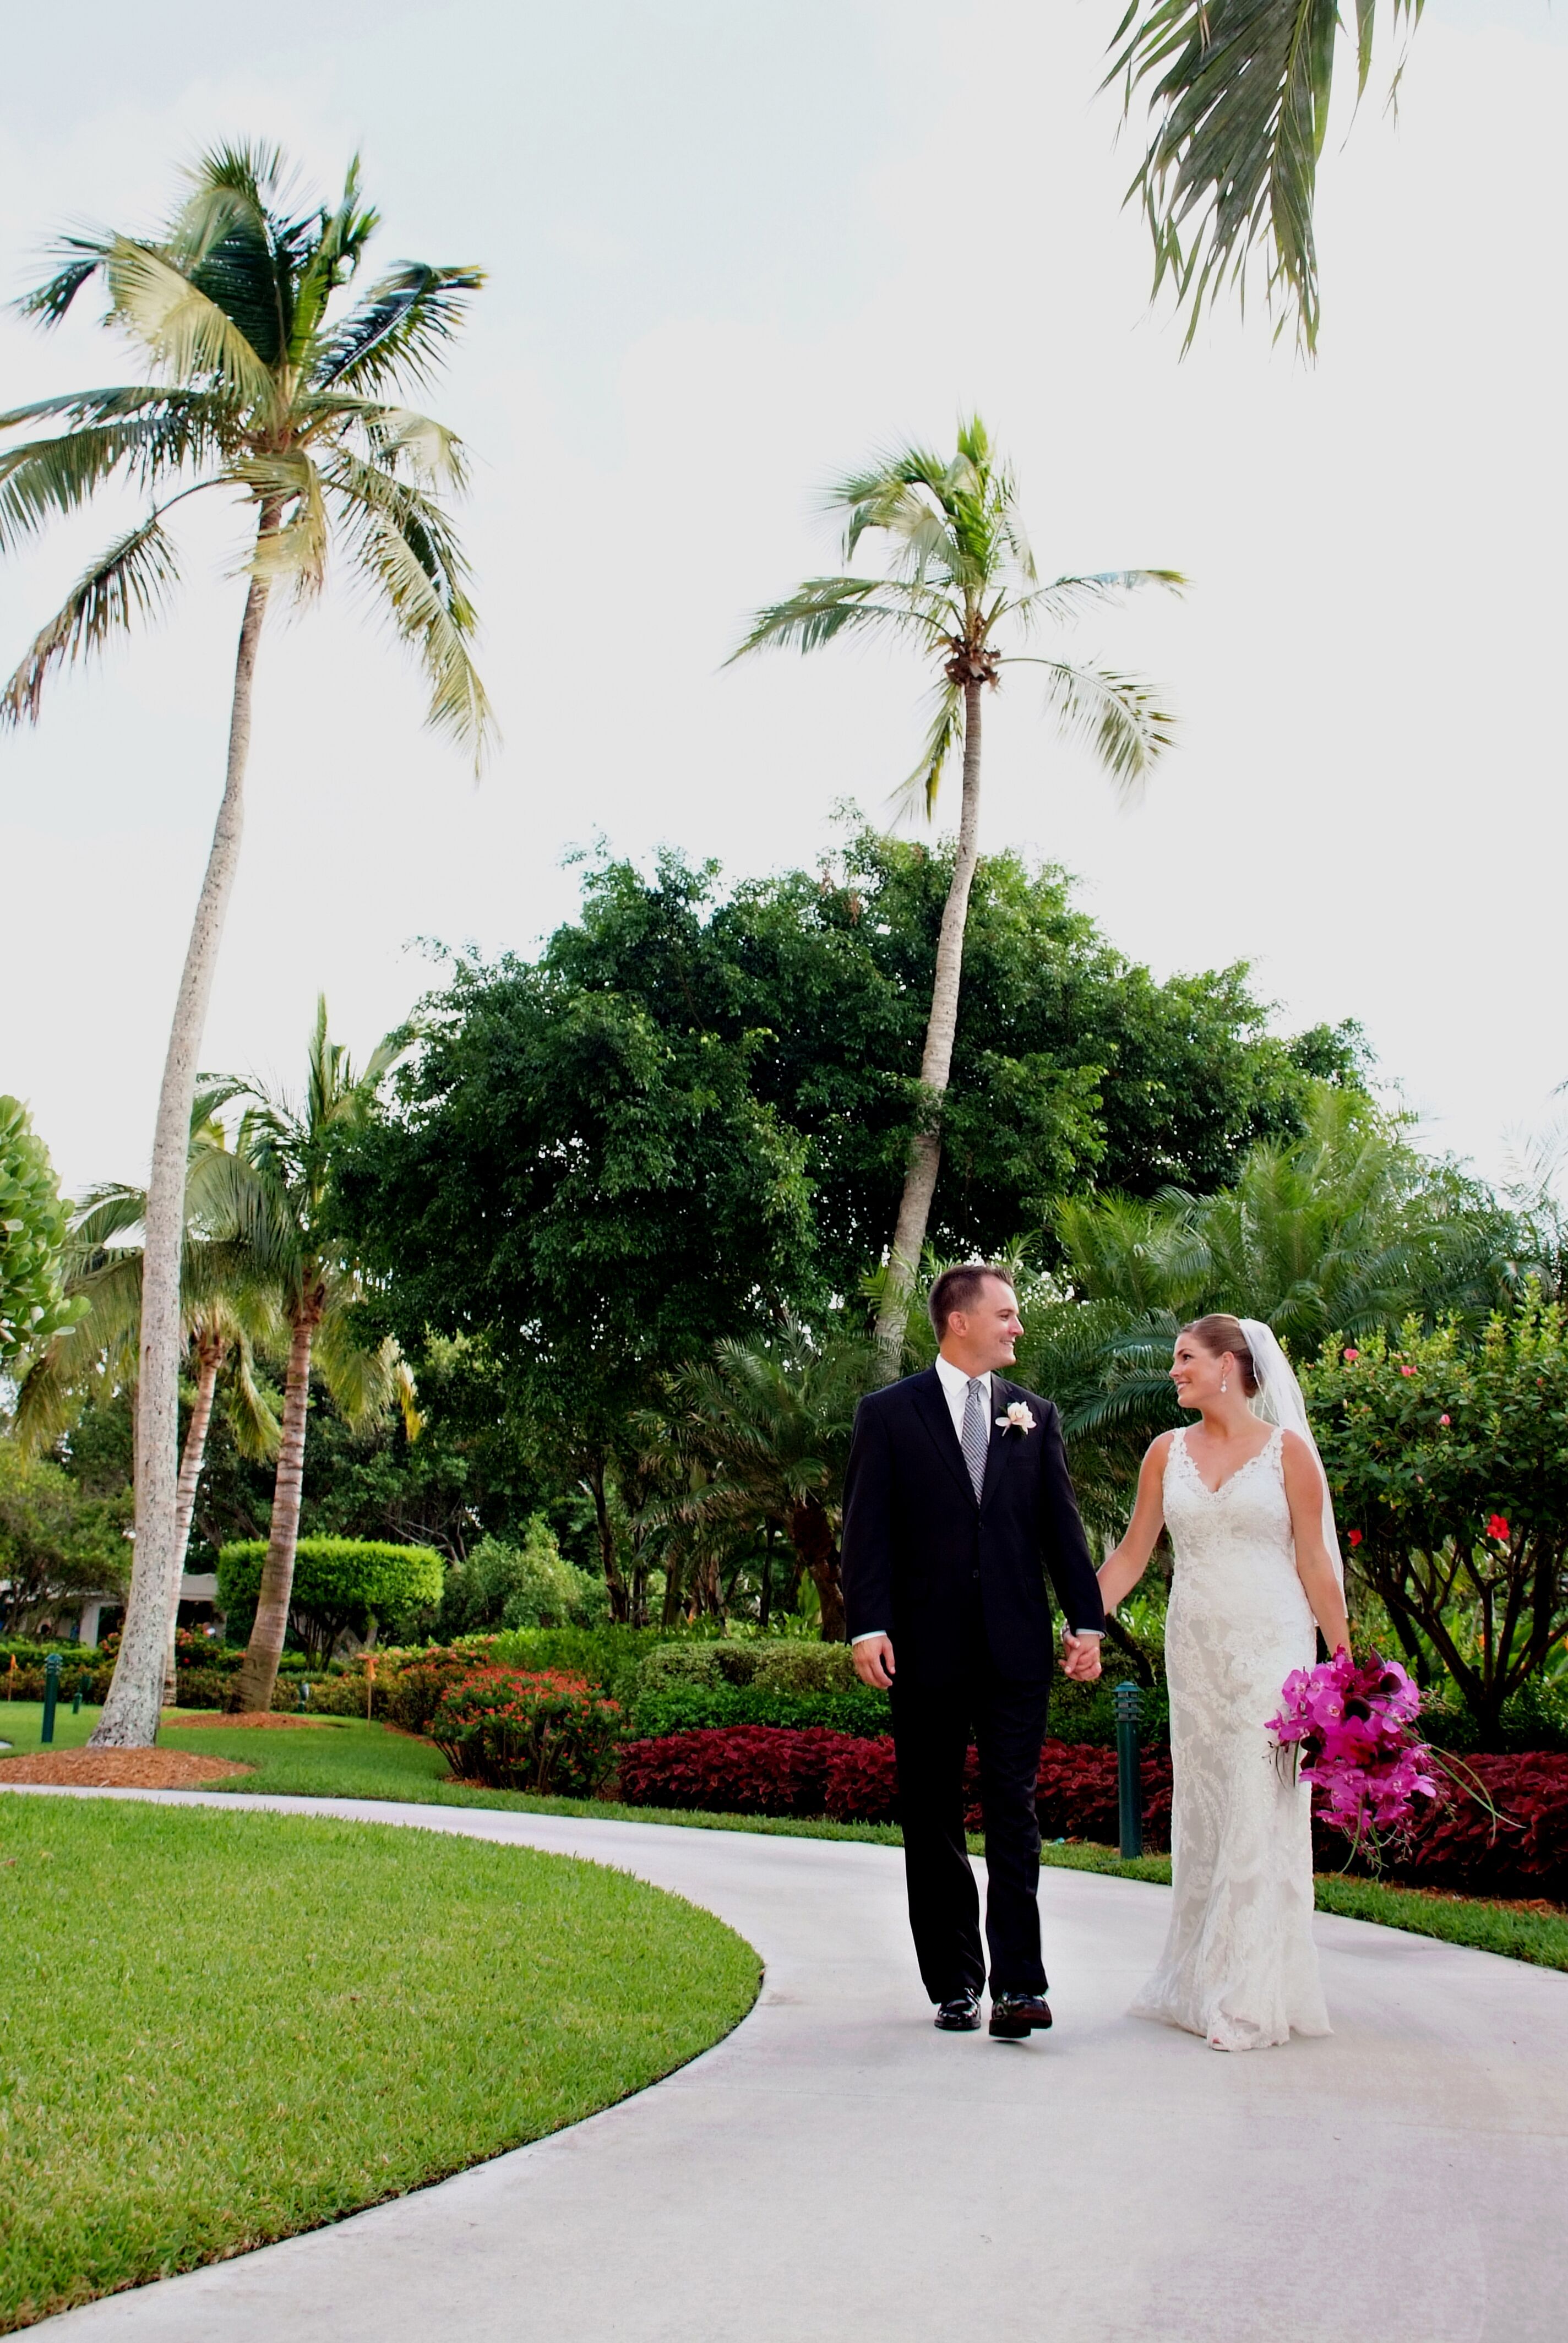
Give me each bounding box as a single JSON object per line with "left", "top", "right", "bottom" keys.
{"left": 0, "top": 145, "right": 490, "bottom": 1746}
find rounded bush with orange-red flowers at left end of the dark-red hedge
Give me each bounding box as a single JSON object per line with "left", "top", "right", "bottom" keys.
{"left": 429, "top": 1666, "right": 621, "bottom": 1797}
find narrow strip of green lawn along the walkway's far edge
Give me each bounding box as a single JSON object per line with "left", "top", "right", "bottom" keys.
{"left": 0, "top": 1701, "right": 1568, "bottom": 1970}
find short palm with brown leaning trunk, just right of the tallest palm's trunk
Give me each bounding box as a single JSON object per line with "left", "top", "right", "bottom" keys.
{"left": 222, "top": 998, "right": 420, "bottom": 1710}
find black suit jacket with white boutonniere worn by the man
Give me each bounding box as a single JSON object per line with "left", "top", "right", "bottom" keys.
{"left": 844, "top": 1366, "right": 1104, "bottom": 1685}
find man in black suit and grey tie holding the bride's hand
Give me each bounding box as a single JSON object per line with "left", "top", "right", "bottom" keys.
{"left": 844, "top": 1263, "right": 1104, "bottom": 2041}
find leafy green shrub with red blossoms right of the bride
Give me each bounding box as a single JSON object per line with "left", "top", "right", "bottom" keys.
{"left": 1301, "top": 1300, "right": 1568, "bottom": 1748}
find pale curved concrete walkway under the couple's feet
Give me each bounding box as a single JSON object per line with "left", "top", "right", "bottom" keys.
{"left": 12, "top": 1792, "right": 1568, "bottom": 2343}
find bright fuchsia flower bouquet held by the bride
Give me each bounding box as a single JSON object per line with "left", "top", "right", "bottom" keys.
{"left": 1268, "top": 1649, "right": 1437, "bottom": 1849}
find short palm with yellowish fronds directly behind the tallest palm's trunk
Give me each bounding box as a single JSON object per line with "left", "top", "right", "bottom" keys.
{"left": 17, "top": 1082, "right": 281, "bottom": 1701}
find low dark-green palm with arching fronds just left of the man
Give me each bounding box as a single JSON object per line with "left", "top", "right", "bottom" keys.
{"left": 647, "top": 1321, "right": 867, "bottom": 1642}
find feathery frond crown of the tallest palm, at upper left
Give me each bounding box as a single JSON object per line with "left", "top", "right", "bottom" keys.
{"left": 0, "top": 145, "right": 490, "bottom": 752}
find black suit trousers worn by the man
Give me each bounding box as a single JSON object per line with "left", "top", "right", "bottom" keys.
{"left": 893, "top": 1638, "right": 1050, "bottom": 2001}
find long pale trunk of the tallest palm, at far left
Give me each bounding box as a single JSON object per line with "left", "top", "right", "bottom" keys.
{"left": 91, "top": 532, "right": 276, "bottom": 1748}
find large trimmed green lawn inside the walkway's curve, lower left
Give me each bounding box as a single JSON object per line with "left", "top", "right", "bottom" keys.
{"left": 0, "top": 1790, "right": 757, "bottom": 2331}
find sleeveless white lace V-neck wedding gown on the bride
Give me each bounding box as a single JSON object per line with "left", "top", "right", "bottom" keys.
{"left": 1132, "top": 1431, "right": 1329, "bottom": 2050}
